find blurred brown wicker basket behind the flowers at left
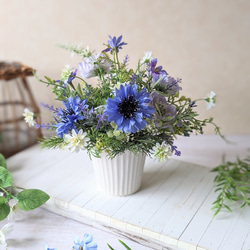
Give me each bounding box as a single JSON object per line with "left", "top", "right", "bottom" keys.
{"left": 0, "top": 62, "right": 42, "bottom": 158}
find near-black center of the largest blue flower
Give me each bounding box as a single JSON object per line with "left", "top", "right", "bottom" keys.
{"left": 117, "top": 96, "right": 139, "bottom": 119}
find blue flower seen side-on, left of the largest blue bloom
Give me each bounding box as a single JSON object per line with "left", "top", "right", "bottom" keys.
{"left": 54, "top": 96, "right": 88, "bottom": 138}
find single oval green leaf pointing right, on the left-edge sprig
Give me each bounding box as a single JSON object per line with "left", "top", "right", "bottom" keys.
{"left": 17, "top": 189, "right": 50, "bottom": 211}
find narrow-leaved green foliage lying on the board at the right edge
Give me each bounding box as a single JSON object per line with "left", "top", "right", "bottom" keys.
{"left": 212, "top": 157, "right": 250, "bottom": 216}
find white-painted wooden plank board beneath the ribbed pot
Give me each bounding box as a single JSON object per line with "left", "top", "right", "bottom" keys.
{"left": 8, "top": 140, "right": 250, "bottom": 250}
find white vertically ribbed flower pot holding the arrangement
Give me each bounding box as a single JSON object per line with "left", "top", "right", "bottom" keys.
{"left": 92, "top": 150, "right": 146, "bottom": 196}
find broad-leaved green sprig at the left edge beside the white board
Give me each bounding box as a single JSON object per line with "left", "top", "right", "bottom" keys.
{"left": 0, "top": 154, "right": 50, "bottom": 221}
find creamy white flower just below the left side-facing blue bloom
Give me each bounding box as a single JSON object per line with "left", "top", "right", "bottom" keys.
{"left": 63, "top": 129, "right": 88, "bottom": 153}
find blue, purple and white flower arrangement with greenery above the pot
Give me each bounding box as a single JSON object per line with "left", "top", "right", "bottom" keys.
{"left": 24, "top": 36, "right": 220, "bottom": 160}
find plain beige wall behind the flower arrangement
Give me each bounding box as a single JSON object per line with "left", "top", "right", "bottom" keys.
{"left": 0, "top": 0, "right": 250, "bottom": 134}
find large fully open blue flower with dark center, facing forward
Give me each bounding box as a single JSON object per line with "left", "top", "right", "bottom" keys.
{"left": 104, "top": 84, "right": 155, "bottom": 133}
